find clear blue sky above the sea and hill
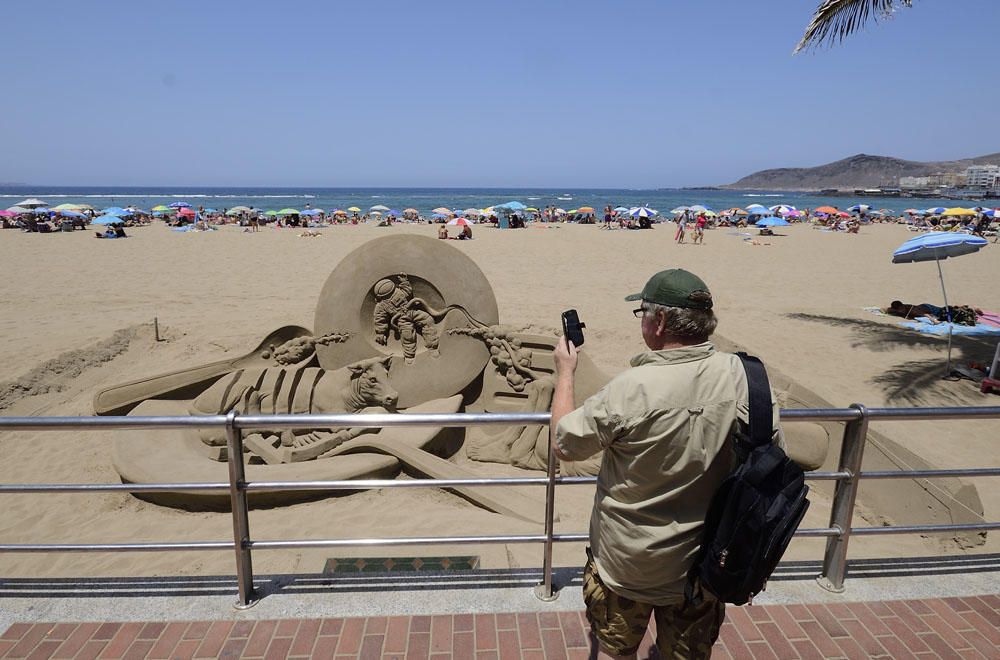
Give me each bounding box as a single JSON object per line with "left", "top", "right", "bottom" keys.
{"left": 0, "top": 0, "right": 1000, "bottom": 188}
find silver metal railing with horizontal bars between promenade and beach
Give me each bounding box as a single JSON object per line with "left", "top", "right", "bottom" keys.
{"left": 0, "top": 404, "right": 1000, "bottom": 608}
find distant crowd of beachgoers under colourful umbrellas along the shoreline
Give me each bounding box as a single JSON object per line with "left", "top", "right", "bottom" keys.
{"left": 0, "top": 198, "right": 1000, "bottom": 243}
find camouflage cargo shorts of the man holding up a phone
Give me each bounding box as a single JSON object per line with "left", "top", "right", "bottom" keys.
{"left": 583, "top": 549, "right": 726, "bottom": 658}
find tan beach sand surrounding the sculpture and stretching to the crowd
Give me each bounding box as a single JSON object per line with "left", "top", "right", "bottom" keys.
{"left": 0, "top": 224, "right": 1000, "bottom": 576}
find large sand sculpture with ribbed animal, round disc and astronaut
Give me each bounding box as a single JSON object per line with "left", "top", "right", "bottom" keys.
{"left": 94, "top": 236, "right": 826, "bottom": 521}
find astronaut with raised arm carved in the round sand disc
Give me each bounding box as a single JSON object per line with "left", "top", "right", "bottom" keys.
{"left": 373, "top": 273, "right": 440, "bottom": 364}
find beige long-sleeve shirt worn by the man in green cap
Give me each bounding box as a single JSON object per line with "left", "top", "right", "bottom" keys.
{"left": 556, "top": 342, "right": 784, "bottom": 604}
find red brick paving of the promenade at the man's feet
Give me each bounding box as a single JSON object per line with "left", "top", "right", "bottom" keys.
{"left": 0, "top": 595, "right": 1000, "bottom": 660}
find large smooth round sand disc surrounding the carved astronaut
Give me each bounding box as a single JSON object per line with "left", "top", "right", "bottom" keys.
{"left": 313, "top": 235, "right": 499, "bottom": 408}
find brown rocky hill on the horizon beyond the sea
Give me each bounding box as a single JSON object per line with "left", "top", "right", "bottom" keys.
{"left": 720, "top": 153, "right": 1000, "bottom": 190}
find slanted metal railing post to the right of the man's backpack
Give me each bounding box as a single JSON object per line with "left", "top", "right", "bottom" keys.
{"left": 816, "top": 403, "right": 868, "bottom": 593}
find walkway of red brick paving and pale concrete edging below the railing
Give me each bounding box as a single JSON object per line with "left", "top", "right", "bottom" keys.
{"left": 0, "top": 555, "right": 1000, "bottom": 660}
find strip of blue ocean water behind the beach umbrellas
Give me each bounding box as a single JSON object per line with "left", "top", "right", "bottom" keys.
{"left": 0, "top": 186, "right": 984, "bottom": 215}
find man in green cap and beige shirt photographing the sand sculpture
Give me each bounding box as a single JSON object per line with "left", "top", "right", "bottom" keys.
{"left": 550, "top": 269, "right": 784, "bottom": 658}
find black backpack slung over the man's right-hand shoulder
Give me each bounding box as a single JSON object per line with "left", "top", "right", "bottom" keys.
{"left": 685, "top": 353, "right": 809, "bottom": 605}
